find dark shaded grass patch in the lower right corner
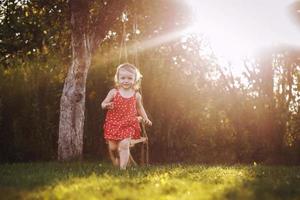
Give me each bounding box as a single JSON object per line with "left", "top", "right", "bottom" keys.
{"left": 224, "top": 166, "right": 300, "bottom": 200}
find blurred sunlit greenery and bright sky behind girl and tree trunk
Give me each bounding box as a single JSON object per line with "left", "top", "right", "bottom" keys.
{"left": 0, "top": 0, "right": 300, "bottom": 164}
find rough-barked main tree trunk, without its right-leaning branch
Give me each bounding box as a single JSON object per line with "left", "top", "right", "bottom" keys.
{"left": 58, "top": 0, "right": 91, "bottom": 160}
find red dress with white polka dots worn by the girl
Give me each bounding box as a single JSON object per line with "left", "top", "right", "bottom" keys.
{"left": 104, "top": 90, "right": 141, "bottom": 141}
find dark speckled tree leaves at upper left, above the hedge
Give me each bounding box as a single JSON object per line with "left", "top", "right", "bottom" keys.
{"left": 0, "top": 0, "right": 70, "bottom": 67}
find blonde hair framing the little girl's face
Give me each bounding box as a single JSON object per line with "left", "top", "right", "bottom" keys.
{"left": 114, "top": 63, "right": 143, "bottom": 90}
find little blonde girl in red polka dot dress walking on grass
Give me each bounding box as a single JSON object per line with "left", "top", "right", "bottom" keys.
{"left": 101, "top": 63, "right": 152, "bottom": 169}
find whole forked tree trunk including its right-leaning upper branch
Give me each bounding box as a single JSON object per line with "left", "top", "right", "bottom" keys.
{"left": 58, "top": 0, "right": 127, "bottom": 160}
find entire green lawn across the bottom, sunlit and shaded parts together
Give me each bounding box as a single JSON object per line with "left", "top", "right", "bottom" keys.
{"left": 0, "top": 162, "right": 300, "bottom": 200}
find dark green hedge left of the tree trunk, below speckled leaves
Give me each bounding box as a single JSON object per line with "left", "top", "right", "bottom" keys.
{"left": 0, "top": 55, "right": 66, "bottom": 161}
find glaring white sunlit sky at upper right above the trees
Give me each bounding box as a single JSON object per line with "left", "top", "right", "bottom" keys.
{"left": 186, "top": 0, "right": 300, "bottom": 75}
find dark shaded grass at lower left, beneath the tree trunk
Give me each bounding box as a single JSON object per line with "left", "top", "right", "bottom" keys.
{"left": 0, "top": 162, "right": 119, "bottom": 199}
